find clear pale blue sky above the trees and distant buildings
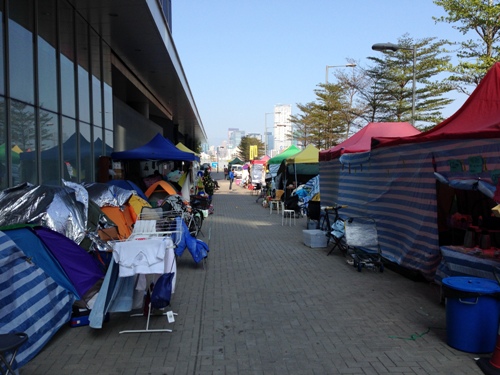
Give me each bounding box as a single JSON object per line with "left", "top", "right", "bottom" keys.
{"left": 172, "top": 0, "right": 466, "bottom": 147}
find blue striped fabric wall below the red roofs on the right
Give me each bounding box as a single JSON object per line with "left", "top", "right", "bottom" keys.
{"left": 320, "top": 139, "right": 500, "bottom": 279}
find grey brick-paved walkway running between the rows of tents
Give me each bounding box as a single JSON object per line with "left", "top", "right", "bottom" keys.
{"left": 20, "top": 173, "right": 482, "bottom": 375}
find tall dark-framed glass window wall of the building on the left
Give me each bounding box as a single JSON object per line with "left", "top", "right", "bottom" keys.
{"left": 0, "top": 0, "right": 113, "bottom": 189}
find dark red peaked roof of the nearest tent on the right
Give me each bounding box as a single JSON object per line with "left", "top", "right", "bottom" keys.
{"left": 375, "top": 63, "right": 500, "bottom": 147}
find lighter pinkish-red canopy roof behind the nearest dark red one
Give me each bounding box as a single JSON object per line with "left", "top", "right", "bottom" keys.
{"left": 319, "top": 122, "right": 420, "bottom": 161}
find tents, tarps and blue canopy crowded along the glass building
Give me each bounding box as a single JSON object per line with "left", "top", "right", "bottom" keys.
{"left": 0, "top": 135, "right": 209, "bottom": 367}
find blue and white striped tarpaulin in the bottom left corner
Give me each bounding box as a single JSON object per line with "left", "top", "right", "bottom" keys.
{"left": 0, "top": 232, "right": 74, "bottom": 367}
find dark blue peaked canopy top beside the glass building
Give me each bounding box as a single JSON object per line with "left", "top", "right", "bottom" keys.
{"left": 111, "top": 133, "right": 196, "bottom": 161}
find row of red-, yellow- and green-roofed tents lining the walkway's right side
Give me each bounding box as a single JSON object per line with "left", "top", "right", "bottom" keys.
{"left": 268, "top": 63, "right": 500, "bottom": 280}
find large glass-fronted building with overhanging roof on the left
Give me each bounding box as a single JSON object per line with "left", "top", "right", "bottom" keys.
{"left": 0, "top": 0, "right": 207, "bottom": 188}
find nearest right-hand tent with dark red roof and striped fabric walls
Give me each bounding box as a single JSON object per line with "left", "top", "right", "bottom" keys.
{"left": 320, "top": 63, "right": 500, "bottom": 279}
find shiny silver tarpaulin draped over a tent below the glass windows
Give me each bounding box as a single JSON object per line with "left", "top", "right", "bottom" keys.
{"left": 0, "top": 183, "right": 88, "bottom": 243}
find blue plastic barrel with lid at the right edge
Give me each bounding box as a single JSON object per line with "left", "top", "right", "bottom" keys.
{"left": 443, "top": 276, "right": 500, "bottom": 353}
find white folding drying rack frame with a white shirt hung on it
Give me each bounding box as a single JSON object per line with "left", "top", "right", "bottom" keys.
{"left": 114, "top": 207, "right": 182, "bottom": 334}
